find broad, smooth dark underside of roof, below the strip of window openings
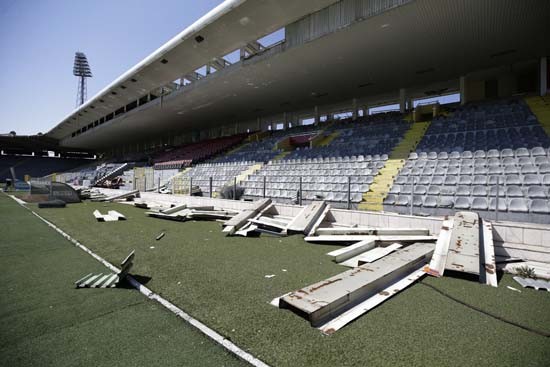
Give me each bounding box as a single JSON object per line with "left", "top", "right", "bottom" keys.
{"left": 50, "top": 0, "right": 550, "bottom": 149}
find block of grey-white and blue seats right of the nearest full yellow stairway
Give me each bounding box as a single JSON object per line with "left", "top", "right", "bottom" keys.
{"left": 384, "top": 100, "right": 550, "bottom": 222}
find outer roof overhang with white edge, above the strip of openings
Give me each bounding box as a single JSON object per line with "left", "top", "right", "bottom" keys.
{"left": 48, "top": 0, "right": 337, "bottom": 139}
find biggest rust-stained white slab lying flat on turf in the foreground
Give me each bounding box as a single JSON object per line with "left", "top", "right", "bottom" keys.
{"left": 280, "top": 243, "right": 434, "bottom": 326}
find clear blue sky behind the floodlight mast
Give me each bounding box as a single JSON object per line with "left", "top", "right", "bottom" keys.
{"left": 0, "top": 0, "right": 223, "bottom": 135}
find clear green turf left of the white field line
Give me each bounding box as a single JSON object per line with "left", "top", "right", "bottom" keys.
{"left": 0, "top": 194, "right": 246, "bottom": 367}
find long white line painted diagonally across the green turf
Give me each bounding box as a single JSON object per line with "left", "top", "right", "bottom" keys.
{"left": 11, "top": 196, "right": 269, "bottom": 367}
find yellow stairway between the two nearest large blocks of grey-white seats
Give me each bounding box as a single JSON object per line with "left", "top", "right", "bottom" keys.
{"left": 359, "top": 121, "right": 430, "bottom": 211}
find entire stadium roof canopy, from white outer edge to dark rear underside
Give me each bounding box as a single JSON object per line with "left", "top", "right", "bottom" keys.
{"left": 47, "top": 0, "right": 550, "bottom": 149}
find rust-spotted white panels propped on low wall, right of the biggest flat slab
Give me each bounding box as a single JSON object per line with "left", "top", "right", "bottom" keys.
{"left": 424, "top": 212, "right": 498, "bottom": 287}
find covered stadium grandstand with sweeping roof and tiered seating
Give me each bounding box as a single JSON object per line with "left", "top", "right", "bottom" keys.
{"left": 2, "top": 0, "right": 550, "bottom": 222}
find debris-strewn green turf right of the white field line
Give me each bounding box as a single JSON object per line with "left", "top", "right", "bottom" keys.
{"left": 21, "top": 202, "right": 550, "bottom": 367}
